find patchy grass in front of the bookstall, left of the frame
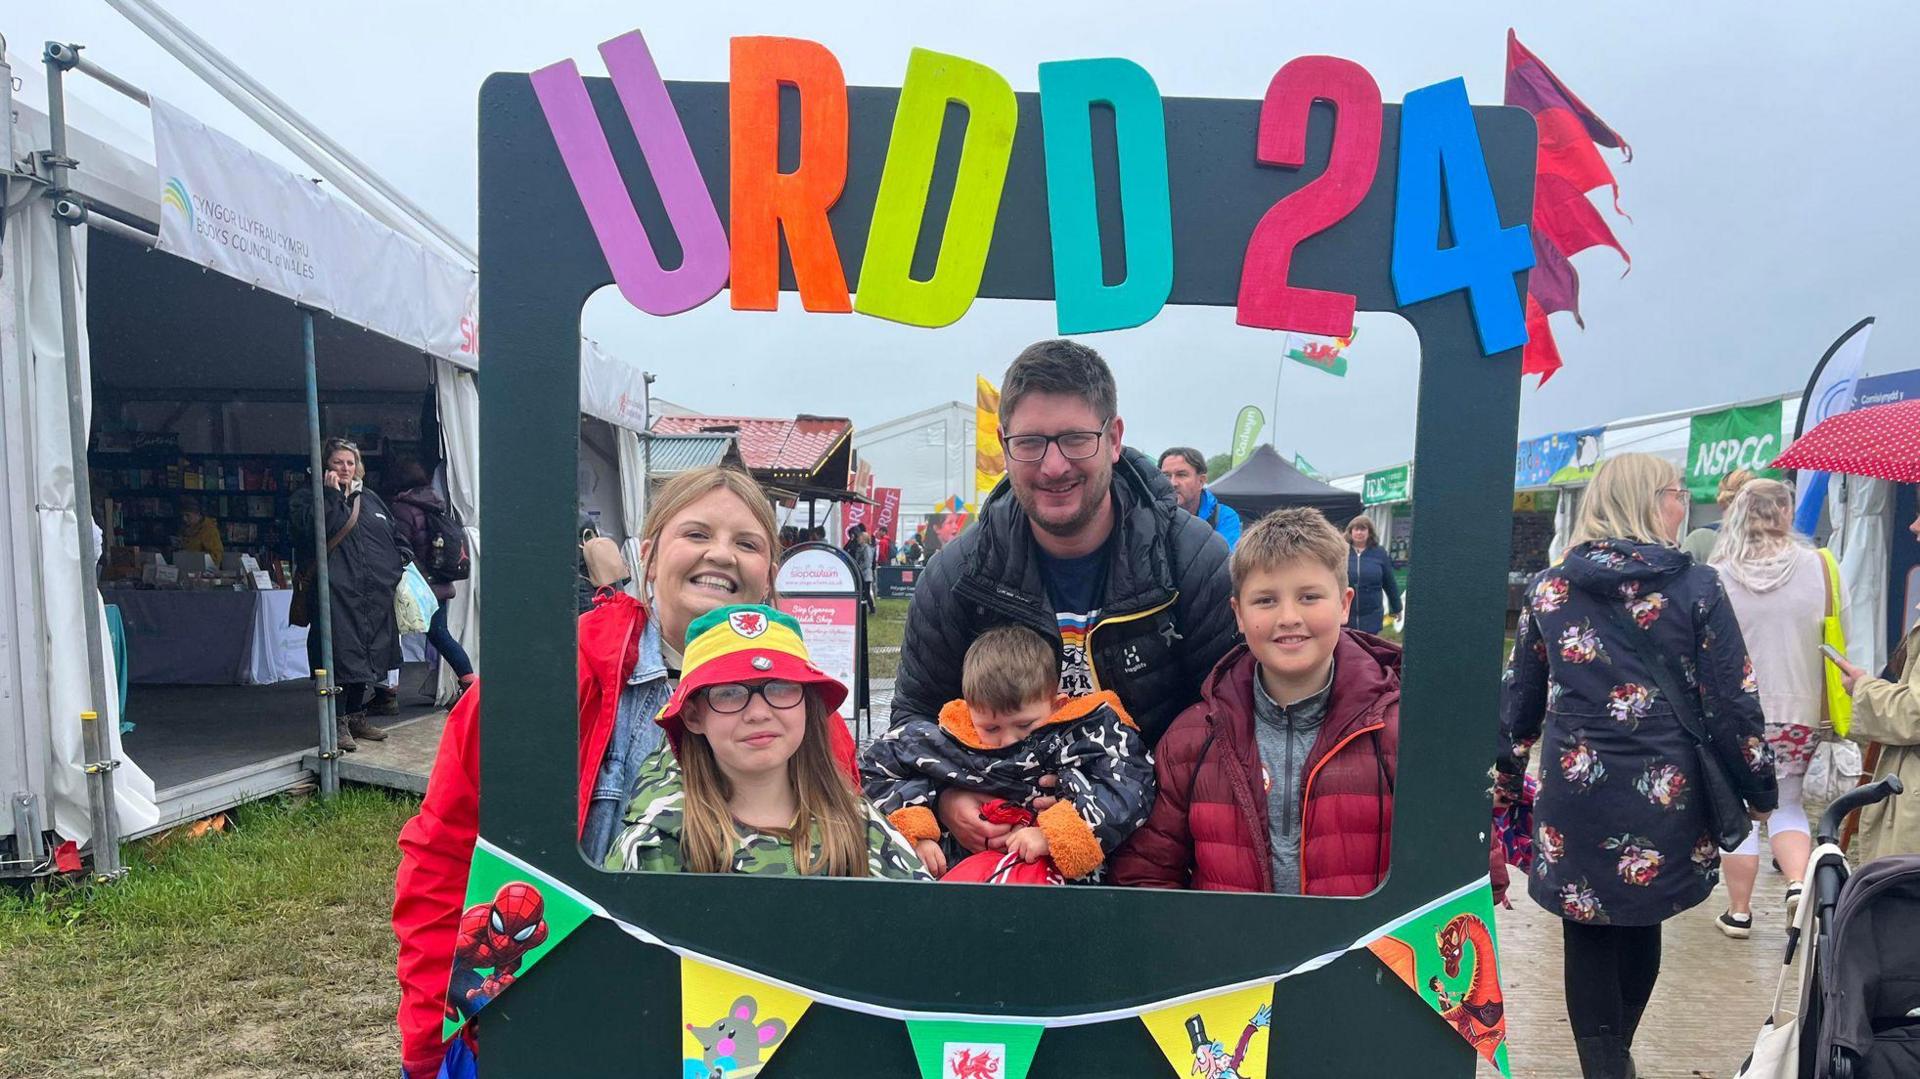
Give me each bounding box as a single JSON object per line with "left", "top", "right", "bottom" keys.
{"left": 0, "top": 789, "right": 415, "bottom": 1079}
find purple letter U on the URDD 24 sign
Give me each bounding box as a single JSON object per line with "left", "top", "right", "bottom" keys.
{"left": 534, "top": 31, "right": 728, "bottom": 315}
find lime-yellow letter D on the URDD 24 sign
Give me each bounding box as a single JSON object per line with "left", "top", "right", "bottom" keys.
{"left": 852, "top": 48, "right": 1020, "bottom": 326}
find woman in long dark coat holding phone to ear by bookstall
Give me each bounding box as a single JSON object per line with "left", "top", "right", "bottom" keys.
{"left": 292, "top": 438, "right": 411, "bottom": 753}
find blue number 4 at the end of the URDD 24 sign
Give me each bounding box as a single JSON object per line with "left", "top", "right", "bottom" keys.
{"left": 1394, "top": 79, "right": 1534, "bottom": 355}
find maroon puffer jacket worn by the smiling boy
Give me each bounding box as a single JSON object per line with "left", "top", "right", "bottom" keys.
{"left": 1110, "top": 630, "right": 1400, "bottom": 895}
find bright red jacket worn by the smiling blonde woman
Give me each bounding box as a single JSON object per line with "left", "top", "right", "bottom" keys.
{"left": 394, "top": 589, "right": 860, "bottom": 1079}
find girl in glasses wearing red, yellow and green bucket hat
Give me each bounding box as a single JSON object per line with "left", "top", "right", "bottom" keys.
{"left": 607, "top": 605, "right": 931, "bottom": 879}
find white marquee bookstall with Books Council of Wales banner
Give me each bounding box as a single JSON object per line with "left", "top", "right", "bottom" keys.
{"left": 0, "top": 54, "right": 503, "bottom": 860}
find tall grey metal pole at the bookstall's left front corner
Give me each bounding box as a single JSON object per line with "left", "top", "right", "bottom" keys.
{"left": 46, "top": 42, "right": 127, "bottom": 881}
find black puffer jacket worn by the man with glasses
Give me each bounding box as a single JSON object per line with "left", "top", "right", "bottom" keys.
{"left": 891, "top": 449, "right": 1238, "bottom": 747}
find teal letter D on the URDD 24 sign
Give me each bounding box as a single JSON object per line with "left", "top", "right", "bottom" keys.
{"left": 1041, "top": 60, "right": 1173, "bottom": 334}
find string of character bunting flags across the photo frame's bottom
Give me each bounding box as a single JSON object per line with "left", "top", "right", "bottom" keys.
{"left": 447, "top": 837, "right": 1507, "bottom": 1079}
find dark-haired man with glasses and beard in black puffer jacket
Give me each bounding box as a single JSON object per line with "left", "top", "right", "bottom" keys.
{"left": 893, "top": 340, "right": 1236, "bottom": 851}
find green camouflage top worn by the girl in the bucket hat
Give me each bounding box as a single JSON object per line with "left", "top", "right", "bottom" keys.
{"left": 605, "top": 745, "right": 933, "bottom": 881}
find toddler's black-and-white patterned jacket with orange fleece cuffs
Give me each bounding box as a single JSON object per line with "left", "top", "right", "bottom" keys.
{"left": 860, "top": 691, "right": 1154, "bottom": 879}
